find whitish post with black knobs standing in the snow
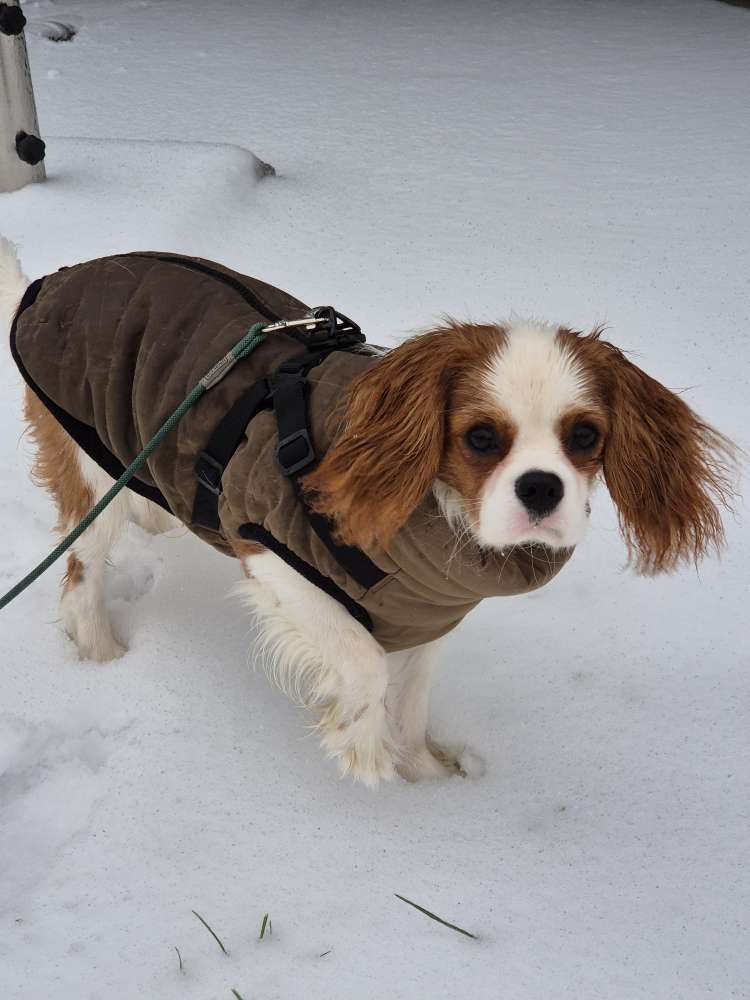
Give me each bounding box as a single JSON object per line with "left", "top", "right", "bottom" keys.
{"left": 0, "top": 0, "right": 45, "bottom": 191}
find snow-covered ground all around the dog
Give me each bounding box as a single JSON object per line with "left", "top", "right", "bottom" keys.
{"left": 0, "top": 0, "right": 750, "bottom": 1000}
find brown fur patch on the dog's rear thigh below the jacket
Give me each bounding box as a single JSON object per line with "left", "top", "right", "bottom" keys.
{"left": 24, "top": 388, "right": 94, "bottom": 533}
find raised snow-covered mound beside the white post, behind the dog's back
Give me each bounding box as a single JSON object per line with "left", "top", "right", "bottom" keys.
{"left": 2, "top": 135, "right": 275, "bottom": 271}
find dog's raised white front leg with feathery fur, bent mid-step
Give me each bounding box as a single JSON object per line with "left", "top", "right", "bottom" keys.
{"left": 238, "top": 547, "right": 397, "bottom": 786}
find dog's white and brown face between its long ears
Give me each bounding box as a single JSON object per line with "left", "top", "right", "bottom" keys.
{"left": 436, "top": 324, "right": 608, "bottom": 549}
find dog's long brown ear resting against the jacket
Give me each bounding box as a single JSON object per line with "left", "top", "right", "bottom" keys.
{"left": 303, "top": 322, "right": 496, "bottom": 548}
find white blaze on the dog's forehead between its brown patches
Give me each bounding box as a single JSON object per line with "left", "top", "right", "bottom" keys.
{"left": 483, "top": 321, "right": 588, "bottom": 434}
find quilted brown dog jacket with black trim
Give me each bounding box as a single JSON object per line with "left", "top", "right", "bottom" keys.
{"left": 11, "top": 253, "right": 570, "bottom": 651}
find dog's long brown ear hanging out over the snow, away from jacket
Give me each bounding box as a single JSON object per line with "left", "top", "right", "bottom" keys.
{"left": 597, "top": 342, "right": 736, "bottom": 575}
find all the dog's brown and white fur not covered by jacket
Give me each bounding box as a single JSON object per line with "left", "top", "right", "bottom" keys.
{"left": 0, "top": 241, "right": 732, "bottom": 785}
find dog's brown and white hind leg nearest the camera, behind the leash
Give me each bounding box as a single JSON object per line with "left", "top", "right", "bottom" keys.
{"left": 25, "top": 389, "right": 131, "bottom": 662}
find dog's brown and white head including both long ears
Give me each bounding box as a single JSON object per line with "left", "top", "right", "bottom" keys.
{"left": 304, "top": 322, "right": 732, "bottom": 573}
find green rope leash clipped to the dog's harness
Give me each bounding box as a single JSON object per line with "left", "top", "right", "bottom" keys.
{"left": 0, "top": 320, "right": 270, "bottom": 610}
